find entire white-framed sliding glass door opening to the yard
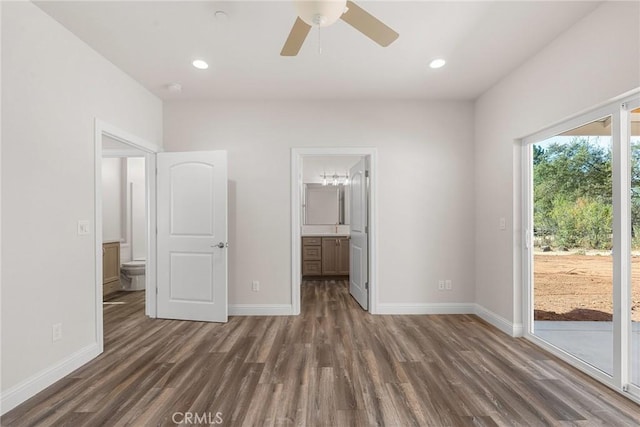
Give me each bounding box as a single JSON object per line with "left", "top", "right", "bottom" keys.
{"left": 523, "top": 94, "right": 640, "bottom": 402}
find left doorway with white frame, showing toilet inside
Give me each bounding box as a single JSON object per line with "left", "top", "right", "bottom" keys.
{"left": 95, "top": 120, "right": 159, "bottom": 351}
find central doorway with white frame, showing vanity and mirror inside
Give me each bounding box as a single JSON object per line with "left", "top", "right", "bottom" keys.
{"left": 291, "top": 148, "right": 376, "bottom": 314}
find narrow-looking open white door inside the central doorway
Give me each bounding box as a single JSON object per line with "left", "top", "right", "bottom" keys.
{"left": 349, "top": 159, "right": 369, "bottom": 310}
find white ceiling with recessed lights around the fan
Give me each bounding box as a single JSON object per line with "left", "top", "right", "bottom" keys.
{"left": 36, "top": 0, "right": 599, "bottom": 99}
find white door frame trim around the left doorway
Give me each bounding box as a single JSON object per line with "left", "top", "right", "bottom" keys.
{"left": 93, "top": 118, "right": 162, "bottom": 353}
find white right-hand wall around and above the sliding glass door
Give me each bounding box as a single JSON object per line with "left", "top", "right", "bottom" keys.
{"left": 475, "top": 2, "right": 640, "bottom": 330}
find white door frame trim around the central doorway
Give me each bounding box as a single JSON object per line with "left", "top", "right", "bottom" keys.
{"left": 291, "top": 147, "right": 378, "bottom": 315}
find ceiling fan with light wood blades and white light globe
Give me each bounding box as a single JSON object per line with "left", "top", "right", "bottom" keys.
{"left": 280, "top": 0, "right": 398, "bottom": 56}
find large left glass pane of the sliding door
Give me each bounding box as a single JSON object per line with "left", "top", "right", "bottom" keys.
{"left": 533, "top": 116, "right": 616, "bottom": 375}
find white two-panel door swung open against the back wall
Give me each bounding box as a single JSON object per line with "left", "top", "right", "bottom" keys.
{"left": 157, "top": 151, "right": 227, "bottom": 322}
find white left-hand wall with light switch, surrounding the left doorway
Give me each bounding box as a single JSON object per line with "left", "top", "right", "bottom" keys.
{"left": 1, "top": 2, "right": 162, "bottom": 411}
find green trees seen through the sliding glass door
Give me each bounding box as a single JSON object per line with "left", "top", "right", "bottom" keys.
{"left": 533, "top": 136, "right": 616, "bottom": 250}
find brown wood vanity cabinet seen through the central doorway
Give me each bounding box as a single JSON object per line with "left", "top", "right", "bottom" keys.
{"left": 302, "top": 236, "right": 349, "bottom": 276}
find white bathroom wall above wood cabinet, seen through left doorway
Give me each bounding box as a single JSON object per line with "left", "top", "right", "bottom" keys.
{"left": 102, "top": 158, "right": 127, "bottom": 242}
